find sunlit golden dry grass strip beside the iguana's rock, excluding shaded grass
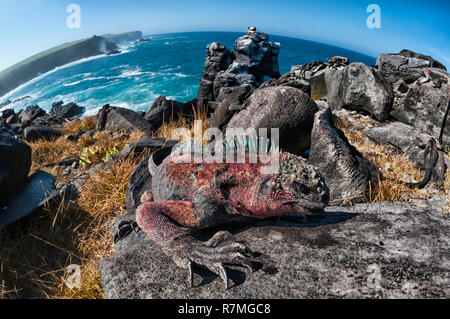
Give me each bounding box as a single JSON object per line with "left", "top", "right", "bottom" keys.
{"left": 54, "top": 157, "right": 142, "bottom": 299}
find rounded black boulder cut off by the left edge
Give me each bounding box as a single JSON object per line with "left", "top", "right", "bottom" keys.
{"left": 0, "top": 126, "right": 31, "bottom": 203}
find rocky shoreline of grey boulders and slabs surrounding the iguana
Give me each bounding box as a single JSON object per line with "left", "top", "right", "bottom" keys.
{"left": 0, "top": 27, "right": 450, "bottom": 298}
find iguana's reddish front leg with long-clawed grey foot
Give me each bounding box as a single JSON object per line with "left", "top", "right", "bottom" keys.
{"left": 136, "top": 201, "right": 253, "bottom": 289}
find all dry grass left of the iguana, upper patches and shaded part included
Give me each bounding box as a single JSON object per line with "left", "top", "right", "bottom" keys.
{"left": 0, "top": 119, "right": 145, "bottom": 298}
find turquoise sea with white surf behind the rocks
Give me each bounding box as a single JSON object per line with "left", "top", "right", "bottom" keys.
{"left": 0, "top": 32, "right": 376, "bottom": 114}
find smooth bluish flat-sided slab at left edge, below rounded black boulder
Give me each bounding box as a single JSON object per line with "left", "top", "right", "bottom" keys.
{"left": 0, "top": 171, "right": 58, "bottom": 229}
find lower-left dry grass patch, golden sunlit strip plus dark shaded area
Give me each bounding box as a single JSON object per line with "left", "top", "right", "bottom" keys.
{"left": 0, "top": 157, "right": 142, "bottom": 299}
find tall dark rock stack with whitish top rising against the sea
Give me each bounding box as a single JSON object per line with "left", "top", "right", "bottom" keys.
{"left": 198, "top": 27, "right": 280, "bottom": 101}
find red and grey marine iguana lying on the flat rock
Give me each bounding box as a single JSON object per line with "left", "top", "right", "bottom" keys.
{"left": 136, "top": 153, "right": 329, "bottom": 287}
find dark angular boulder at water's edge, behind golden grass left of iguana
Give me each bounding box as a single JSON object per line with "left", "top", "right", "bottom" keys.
{"left": 96, "top": 104, "right": 153, "bottom": 134}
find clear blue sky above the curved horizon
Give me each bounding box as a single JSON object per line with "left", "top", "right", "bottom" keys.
{"left": 0, "top": 0, "right": 450, "bottom": 70}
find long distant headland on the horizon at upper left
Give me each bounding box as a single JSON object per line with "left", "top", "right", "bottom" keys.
{"left": 0, "top": 31, "right": 142, "bottom": 97}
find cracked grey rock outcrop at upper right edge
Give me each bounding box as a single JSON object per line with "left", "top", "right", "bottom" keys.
{"left": 377, "top": 50, "right": 450, "bottom": 148}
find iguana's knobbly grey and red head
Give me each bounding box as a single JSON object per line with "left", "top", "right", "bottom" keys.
{"left": 237, "top": 153, "right": 330, "bottom": 217}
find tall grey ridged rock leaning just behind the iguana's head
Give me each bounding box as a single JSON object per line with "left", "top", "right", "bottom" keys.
{"left": 309, "top": 108, "right": 380, "bottom": 204}
